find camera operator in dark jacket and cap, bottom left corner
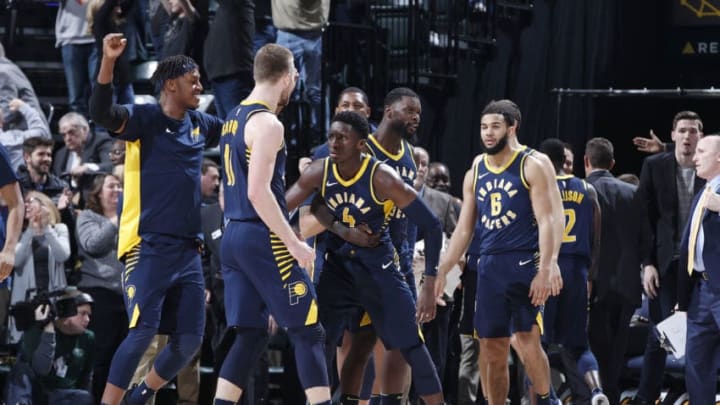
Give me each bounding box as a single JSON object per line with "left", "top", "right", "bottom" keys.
{"left": 6, "top": 288, "right": 95, "bottom": 405}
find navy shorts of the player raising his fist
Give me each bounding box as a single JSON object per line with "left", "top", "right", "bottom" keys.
{"left": 122, "top": 235, "right": 205, "bottom": 336}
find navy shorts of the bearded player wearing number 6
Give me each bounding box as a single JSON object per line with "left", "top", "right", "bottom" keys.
{"left": 475, "top": 252, "right": 543, "bottom": 338}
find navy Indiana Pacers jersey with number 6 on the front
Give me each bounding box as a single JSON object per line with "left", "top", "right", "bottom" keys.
{"left": 473, "top": 149, "right": 538, "bottom": 255}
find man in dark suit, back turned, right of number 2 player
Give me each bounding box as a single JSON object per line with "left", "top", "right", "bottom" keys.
{"left": 584, "top": 138, "right": 649, "bottom": 404}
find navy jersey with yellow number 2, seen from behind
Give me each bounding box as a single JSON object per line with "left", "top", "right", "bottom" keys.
{"left": 557, "top": 175, "right": 593, "bottom": 259}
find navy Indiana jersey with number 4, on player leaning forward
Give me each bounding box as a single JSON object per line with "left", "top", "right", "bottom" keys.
{"left": 320, "top": 155, "right": 395, "bottom": 240}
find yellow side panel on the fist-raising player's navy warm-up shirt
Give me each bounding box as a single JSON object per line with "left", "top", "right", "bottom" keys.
{"left": 118, "top": 139, "right": 142, "bottom": 259}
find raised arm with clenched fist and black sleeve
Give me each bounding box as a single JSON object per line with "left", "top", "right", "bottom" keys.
{"left": 90, "top": 34, "right": 129, "bottom": 133}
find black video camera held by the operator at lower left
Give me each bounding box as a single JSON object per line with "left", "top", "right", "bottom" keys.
{"left": 10, "top": 288, "right": 92, "bottom": 331}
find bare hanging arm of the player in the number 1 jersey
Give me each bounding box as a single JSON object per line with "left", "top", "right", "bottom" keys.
{"left": 245, "top": 113, "right": 315, "bottom": 269}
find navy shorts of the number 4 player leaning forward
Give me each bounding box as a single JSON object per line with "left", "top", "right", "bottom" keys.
{"left": 319, "top": 242, "right": 422, "bottom": 349}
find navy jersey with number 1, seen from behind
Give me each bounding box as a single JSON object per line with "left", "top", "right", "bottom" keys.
{"left": 220, "top": 100, "right": 288, "bottom": 221}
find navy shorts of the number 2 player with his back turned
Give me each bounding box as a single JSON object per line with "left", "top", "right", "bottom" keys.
{"left": 543, "top": 256, "right": 588, "bottom": 349}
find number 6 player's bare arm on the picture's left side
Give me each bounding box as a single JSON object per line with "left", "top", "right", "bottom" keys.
{"left": 435, "top": 165, "right": 477, "bottom": 297}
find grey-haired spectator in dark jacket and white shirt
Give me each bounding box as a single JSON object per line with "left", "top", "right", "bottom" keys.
{"left": 53, "top": 112, "right": 113, "bottom": 178}
